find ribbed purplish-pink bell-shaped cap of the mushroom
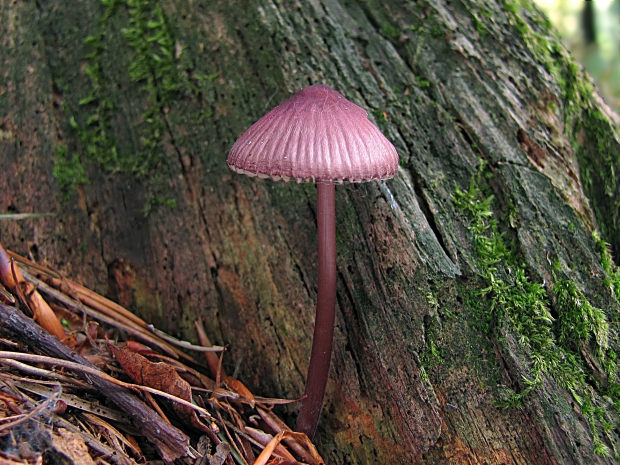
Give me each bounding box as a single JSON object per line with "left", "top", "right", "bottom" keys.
{"left": 228, "top": 84, "right": 398, "bottom": 183}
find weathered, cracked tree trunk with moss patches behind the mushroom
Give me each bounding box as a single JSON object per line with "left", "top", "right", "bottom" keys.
{"left": 0, "top": 0, "right": 620, "bottom": 465}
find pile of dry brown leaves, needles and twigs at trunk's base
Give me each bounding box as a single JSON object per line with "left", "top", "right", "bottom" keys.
{"left": 0, "top": 244, "right": 324, "bottom": 465}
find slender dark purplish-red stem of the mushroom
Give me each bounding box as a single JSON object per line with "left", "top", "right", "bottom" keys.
{"left": 295, "top": 182, "right": 336, "bottom": 439}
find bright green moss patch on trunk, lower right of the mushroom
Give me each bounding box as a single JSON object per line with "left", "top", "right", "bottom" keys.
{"left": 453, "top": 163, "right": 620, "bottom": 455}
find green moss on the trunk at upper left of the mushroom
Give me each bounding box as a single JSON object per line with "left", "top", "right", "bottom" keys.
{"left": 60, "top": 0, "right": 216, "bottom": 212}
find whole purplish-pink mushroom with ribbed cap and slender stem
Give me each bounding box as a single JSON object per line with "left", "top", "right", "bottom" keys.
{"left": 228, "top": 84, "right": 398, "bottom": 438}
